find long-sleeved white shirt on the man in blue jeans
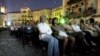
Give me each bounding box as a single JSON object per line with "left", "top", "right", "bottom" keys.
{"left": 37, "top": 23, "right": 52, "bottom": 39}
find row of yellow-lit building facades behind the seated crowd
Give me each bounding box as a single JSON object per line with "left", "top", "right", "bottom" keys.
{"left": 6, "top": 0, "right": 100, "bottom": 22}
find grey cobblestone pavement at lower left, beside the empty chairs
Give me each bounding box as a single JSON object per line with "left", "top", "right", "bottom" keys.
{"left": 0, "top": 31, "right": 45, "bottom": 56}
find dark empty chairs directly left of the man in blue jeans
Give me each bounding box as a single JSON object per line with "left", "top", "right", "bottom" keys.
{"left": 9, "top": 27, "right": 47, "bottom": 50}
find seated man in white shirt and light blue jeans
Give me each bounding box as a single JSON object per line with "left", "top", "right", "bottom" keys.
{"left": 37, "top": 16, "right": 59, "bottom": 56}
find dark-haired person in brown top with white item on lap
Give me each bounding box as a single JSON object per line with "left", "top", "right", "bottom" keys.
{"left": 52, "top": 18, "right": 75, "bottom": 56}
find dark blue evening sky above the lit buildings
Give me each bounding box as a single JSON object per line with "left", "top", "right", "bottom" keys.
{"left": 6, "top": 0, "right": 62, "bottom": 12}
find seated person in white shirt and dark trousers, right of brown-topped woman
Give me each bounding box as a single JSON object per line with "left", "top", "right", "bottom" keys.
{"left": 71, "top": 19, "right": 89, "bottom": 46}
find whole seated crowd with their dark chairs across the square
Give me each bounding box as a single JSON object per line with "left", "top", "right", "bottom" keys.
{"left": 10, "top": 16, "right": 100, "bottom": 56}
